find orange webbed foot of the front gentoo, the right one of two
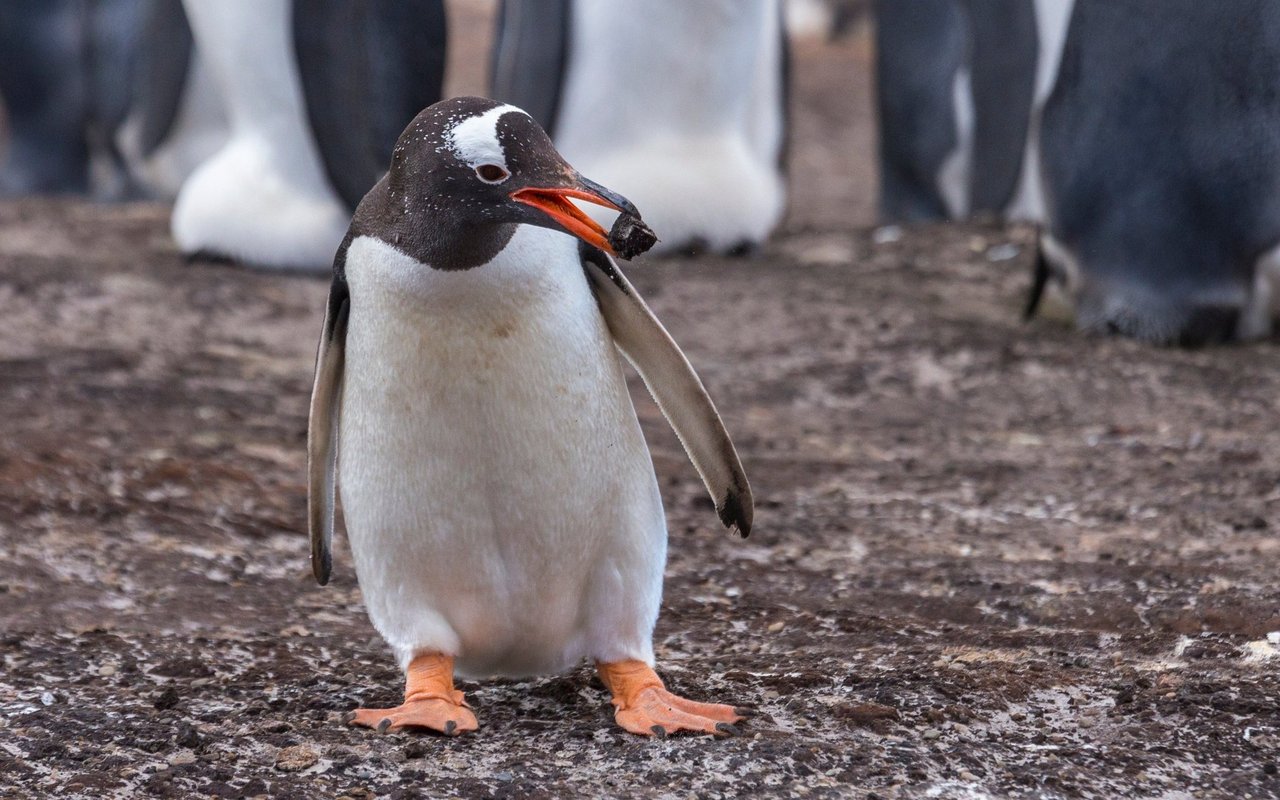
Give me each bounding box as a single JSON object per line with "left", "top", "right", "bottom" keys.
{"left": 595, "top": 660, "right": 746, "bottom": 737}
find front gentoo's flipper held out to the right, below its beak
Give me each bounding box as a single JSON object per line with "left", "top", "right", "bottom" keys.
{"left": 579, "top": 244, "right": 755, "bottom": 539}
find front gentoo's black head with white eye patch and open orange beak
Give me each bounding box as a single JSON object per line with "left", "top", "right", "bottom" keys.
{"left": 352, "top": 97, "right": 639, "bottom": 269}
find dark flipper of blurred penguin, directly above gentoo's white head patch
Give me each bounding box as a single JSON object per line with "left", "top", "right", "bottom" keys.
{"left": 489, "top": 0, "right": 573, "bottom": 137}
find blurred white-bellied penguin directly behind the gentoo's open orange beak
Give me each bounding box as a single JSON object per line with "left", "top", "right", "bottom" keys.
{"left": 492, "top": 0, "right": 787, "bottom": 252}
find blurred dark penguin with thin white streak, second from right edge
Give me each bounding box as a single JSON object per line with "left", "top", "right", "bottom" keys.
{"left": 876, "top": 0, "right": 1055, "bottom": 221}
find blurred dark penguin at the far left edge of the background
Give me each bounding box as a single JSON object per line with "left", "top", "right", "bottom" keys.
{"left": 0, "top": 0, "right": 146, "bottom": 200}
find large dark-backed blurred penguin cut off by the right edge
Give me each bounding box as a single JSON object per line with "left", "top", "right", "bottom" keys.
{"left": 1029, "top": 0, "right": 1280, "bottom": 346}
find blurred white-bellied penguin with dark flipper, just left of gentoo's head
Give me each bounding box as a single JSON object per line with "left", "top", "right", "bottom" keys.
{"left": 172, "top": 0, "right": 444, "bottom": 270}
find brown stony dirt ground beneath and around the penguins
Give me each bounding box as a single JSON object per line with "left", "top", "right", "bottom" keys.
{"left": 0, "top": 18, "right": 1280, "bottom": 800}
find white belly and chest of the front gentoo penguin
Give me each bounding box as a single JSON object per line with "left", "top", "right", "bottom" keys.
{"left": 338, "top": 225, "right": 667, "bottom": 677}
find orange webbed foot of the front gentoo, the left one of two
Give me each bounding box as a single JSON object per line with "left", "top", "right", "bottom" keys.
{"left": 346, "top": 653, "right": 480, "bottom": 736}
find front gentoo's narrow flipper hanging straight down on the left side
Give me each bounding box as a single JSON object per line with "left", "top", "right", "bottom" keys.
{"left": 307, "top": 273, "right": 351, "bottom": 586}
